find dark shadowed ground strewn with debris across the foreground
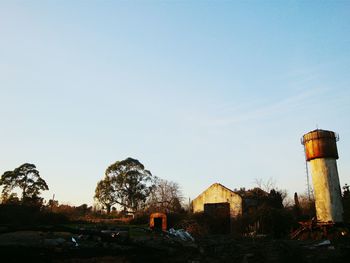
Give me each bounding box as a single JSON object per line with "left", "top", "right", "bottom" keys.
{"left": 0, "top": 228, "right": 350, "bottom": 263}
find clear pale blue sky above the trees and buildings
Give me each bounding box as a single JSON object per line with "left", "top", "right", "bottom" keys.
{"left": 0, "top": 0, "right": 350, "bottom": 205}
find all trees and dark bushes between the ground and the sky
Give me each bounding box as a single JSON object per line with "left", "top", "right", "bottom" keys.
{"left": 0, "top": 158, "right": 350, "bottom": 242}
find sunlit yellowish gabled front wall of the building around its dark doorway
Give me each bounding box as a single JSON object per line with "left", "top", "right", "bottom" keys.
{"left": 192, "top": 183, "right": 242, "bottom": 217}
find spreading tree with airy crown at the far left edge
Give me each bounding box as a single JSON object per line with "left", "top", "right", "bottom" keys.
{"left": 0, "top": 163, "right": 49, "bottom": 203}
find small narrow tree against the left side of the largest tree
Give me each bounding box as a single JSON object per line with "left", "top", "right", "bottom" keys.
{"left": 95, "top": 176, "right": 118, "bottom": 214}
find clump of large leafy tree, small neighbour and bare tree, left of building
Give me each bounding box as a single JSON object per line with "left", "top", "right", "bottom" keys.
{"left": 95, "top": 158, "right": 182, "bottom": 214}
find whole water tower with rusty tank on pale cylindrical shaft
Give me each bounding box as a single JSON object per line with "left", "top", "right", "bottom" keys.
{"left": 301, "top": 129, "right": 343, "bottom": 223}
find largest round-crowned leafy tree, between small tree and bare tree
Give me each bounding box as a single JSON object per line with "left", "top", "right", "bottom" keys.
{"left": 99, "top": 158, "right": 154, "bottom": 212}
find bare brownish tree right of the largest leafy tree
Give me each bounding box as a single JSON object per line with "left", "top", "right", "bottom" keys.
{"left": 147, "top": 177, "right": 183, "bottom": 213}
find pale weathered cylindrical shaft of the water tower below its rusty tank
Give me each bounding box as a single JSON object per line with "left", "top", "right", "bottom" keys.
{"left": 310, "top": 158, "right": 343, "bottom": 222}
